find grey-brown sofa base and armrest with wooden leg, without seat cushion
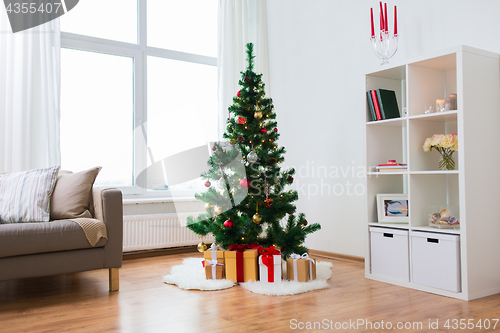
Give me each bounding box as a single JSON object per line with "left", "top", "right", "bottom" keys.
{"left": 0, "top": 189, "right": 123, "bottom": 291}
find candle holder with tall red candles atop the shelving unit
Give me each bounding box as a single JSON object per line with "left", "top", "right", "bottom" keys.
{"left": 370, "top": 2, "right": 398, "bottom": 65}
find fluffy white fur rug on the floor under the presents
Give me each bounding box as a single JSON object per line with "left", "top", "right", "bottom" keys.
{"left": 163, "top": 258, "right": 332, "bottom": 296}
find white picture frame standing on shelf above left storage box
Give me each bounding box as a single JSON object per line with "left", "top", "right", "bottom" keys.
{"left": 377, "top": 193, "right": 409, "bottom": 223}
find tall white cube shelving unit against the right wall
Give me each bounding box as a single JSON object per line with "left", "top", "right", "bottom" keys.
{"left": 363, "top": 46, "right": 500, "bottom": 300}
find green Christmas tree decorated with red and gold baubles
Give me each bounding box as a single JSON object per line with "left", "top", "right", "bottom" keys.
{"left": 188, "top": 43, "right": 321, "bottom": 259}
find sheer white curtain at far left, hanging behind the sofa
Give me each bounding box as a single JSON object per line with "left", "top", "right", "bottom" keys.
{"left": 0, "top": 9, "right": 61, "bottom": 172}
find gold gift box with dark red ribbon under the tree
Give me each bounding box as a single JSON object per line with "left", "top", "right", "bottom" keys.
{"left": 224, "top": 244, "right": 260, "bottom": 282}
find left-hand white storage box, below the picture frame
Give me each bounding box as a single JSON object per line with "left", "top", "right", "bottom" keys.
{"left": 370, "top": 227, "right": 410, "bottom": 281}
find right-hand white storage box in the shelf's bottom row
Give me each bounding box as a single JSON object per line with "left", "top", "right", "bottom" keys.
{"left": 411, "top": 232, "right": 462, "bottom": 293}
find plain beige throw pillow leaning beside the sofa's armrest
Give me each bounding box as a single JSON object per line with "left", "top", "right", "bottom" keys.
{"left": 50, "top": 167, "right": 101, "bottom": 220}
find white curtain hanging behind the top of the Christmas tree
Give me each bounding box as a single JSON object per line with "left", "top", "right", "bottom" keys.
{"left": 217, "top": 0, "right": 270, "bottom": 139}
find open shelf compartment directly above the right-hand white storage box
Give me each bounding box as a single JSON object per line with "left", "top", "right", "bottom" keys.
{"left": 409, "top": 174, "right": 461, "bottom": 233}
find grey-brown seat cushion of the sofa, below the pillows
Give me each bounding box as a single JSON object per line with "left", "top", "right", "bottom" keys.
{"left": 0, "top": 220, "right": 106, "bottom": 258}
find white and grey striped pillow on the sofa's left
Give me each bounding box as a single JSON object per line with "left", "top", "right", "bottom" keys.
{"left": 0, "top": 166, "right": 59, "bottom": 223}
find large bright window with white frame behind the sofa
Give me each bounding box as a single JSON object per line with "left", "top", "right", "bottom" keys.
{"left": 61, "top": 0, "right": 217, "bottom": 195}
